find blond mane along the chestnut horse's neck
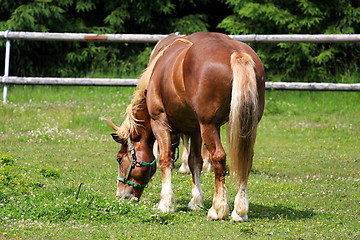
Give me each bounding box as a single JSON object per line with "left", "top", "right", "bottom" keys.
{"left": 117, "top": 38, "right": 193, "bottom": 139}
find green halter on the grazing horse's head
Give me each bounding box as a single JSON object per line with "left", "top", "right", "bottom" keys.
{"left": 117, "top": 139, "right": 156, "bottom": 188}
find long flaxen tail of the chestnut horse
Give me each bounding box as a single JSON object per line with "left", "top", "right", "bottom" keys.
{"left": 228, "top": 52, "right": 259, "bottom": 185}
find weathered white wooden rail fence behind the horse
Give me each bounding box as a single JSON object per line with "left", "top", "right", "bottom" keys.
{"left": 0, "top": 31, "right": 360, "bottom": 103}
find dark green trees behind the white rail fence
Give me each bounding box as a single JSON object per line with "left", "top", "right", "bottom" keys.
{"left": 0, "top": 0, "right": 360, "bottom": 82}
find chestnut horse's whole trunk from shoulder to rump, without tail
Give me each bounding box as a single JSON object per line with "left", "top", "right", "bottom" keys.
{"left": 148, "top": 32, "right": 264, "bottom": 132}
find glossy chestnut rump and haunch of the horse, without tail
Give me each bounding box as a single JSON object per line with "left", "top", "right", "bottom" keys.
{"left": 183, "top": 34, "right": 264, "bottom": 125}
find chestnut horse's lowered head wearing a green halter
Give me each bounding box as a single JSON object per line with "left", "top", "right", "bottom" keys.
{"left": 108, "top": 100, "right": 156, "bottom": 201}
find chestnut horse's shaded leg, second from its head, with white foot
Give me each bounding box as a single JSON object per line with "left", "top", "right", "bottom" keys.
{"left": 188, "top": 134, "right": 204, "bottom": 210}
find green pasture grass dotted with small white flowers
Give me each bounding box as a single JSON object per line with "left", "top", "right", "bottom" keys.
{"left": 0, "top": 86, "right": 360, "bottom": 239}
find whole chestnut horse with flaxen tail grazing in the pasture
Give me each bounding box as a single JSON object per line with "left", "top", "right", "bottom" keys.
{"left": 109, "top": 32, "right": 265, "bottom": 221}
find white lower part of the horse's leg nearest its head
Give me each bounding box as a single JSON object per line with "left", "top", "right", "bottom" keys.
{"left": 158, "top": 169, "right": 175, "bottom": 212}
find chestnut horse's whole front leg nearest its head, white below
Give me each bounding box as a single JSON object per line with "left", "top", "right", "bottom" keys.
{"left": 151, "top": 120, "right": 175, "bottom": 212}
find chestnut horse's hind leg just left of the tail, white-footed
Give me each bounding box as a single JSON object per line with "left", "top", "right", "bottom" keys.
{"left": 200, "top": 125, "right": 229, "bottom": 220}
